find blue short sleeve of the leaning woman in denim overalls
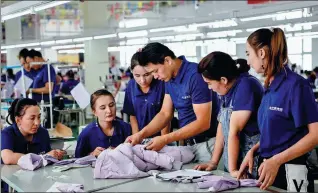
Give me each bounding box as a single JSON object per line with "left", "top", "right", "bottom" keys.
{"left": 233, "top": 79, "right": 263, "bottom": 112}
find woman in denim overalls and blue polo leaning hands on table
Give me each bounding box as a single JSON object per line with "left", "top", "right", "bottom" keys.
{"left": 195, "top": 52, "right": 264, "bottom": 178}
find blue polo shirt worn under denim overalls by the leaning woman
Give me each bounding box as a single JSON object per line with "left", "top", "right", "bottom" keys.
{"left": 220, "top": 73, "right": 264, "bottom": 136}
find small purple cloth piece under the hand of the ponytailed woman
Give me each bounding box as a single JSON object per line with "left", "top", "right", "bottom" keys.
{"left": 198, "top": 176, "right": 259, "bottom": 192}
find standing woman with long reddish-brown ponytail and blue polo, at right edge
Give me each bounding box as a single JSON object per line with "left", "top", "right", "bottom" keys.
{"left": 239, "top": 28, "right": 318, "bottom": 192}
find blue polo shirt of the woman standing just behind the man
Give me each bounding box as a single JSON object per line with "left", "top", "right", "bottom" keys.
{"left": 123, "top": 79, "right": 165, "bottom": 137}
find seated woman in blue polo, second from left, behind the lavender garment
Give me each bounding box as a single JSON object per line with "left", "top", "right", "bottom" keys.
{"left": 75, "top": 89, "right": 131, "bottom": 157}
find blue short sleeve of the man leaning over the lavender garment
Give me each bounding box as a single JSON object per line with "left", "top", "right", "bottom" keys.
{"left": 190, "top": 73, "right": 212, "bottom": 104}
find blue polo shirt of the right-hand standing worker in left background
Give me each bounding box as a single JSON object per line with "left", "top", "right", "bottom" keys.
{"left": 32, "top": 65, "right": 56, "bottom": 102}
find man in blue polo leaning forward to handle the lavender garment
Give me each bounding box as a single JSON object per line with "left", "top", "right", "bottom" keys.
{"left": 126, "top": 43, "right": 219, "bottom": 162}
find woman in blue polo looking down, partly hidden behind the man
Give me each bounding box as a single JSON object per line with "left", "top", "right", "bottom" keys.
{"left": 123, "top": 52, "right": 170, "bottom": 138}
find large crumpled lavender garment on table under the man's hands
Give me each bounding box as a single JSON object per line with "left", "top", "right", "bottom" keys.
{"left": 94, "top": 143, "right": 194, "bottom": 178}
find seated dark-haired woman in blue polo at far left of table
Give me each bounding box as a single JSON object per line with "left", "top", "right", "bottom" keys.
{"left": 1, "top": 98, "right": 64, "bottom": 165}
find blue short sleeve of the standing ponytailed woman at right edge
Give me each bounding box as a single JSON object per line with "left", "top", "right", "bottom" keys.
{"left": 290, "top": 83, "right": 318, "bottom": 127}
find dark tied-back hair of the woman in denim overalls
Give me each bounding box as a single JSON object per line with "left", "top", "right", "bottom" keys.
{"left": 198, "top": 51, "right": 250, "bottom": 81}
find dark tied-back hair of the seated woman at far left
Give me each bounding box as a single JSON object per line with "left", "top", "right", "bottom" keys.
{"left": 6, "top": 98, "right": 38, "bottom": 125}
